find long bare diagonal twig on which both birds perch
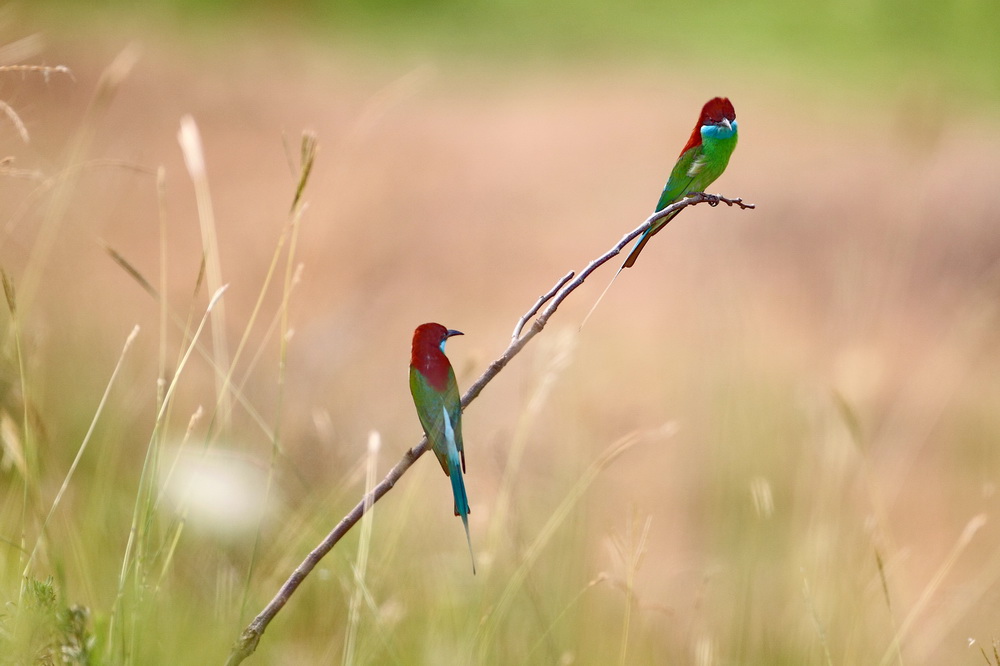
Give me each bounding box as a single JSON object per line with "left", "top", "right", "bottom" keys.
{"left": 226, "top": 192, "right": 755, "bottom": 666}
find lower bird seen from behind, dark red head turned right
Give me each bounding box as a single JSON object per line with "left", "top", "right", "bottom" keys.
{"left": 410, "top": 322, "right": 476, "bottom": 574}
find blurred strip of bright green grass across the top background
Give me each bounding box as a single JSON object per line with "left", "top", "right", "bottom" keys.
{"left": 27, "top": 0, "right": 1000, "bottom": 106}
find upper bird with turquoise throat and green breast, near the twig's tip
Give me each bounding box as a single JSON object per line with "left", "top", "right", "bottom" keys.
{"left": 580, "top": 97, "right": 739, "bottom": 328}
